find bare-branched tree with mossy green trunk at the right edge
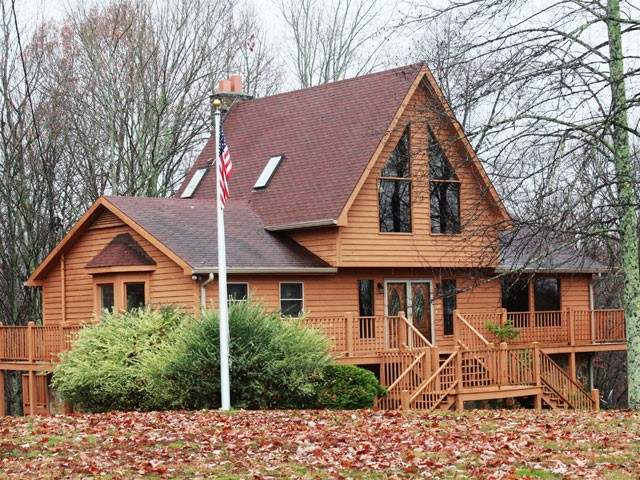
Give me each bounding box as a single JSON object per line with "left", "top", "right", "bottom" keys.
{"left": 412, "top": 0, "right": 640, "bottom": 409}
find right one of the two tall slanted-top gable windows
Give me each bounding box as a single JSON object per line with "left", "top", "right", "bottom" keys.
{"left": 428, "top": 130, "right": 460, "bottom": 234}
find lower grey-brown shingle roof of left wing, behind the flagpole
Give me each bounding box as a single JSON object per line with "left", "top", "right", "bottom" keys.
{"left": 105, "top": 197, "right": 330, "bottom": 271}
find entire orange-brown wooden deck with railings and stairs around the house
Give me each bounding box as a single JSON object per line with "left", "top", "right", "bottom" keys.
{"left": 0, "top": 309, "right": 626, "bottom": 415}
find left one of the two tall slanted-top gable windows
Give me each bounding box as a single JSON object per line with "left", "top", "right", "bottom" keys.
{"left": 378, "top": 127, "right": 411, "bottom": 233}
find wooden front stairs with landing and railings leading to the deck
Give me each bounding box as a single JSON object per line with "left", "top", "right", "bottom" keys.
{"left": 377, "top": 312, "right": 598, "bottom": 411}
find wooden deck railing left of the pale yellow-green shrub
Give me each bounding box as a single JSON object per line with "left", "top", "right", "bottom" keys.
{"left": 0, "top": 322, "right": 83, "bottom": 363}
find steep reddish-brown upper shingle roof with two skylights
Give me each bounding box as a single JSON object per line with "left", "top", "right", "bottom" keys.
{"left": 178, "top": 65, "right": 422, "bottom": 227}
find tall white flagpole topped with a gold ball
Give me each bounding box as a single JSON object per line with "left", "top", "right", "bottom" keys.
{"left": 213, "top": 99, "right": 231, "bottom": 410}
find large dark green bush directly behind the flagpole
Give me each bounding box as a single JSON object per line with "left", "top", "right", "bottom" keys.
{"left": 153, "top": 302, "right": 331, "bottom": 409}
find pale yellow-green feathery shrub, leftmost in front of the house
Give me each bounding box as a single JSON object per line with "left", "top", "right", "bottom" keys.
{"left": 53, "top": 307, "right": 191, "bottom": 412}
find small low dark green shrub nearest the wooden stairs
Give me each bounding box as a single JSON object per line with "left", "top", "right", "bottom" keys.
{"left": 318, "top": 365, "right": 387, "bottom": 410}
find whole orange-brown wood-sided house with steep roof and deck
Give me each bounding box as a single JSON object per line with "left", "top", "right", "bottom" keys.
{"left": 0, "top": 65, "right": 626, "bottom": 414}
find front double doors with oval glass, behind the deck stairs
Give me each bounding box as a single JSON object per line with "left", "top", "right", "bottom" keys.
{"left": 385, "top": 280, "right": 434, "bottom": 343}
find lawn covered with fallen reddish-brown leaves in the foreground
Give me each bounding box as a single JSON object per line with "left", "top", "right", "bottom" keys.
{"left": 0, "top": 410, "right": 640, "bottom": 479}
